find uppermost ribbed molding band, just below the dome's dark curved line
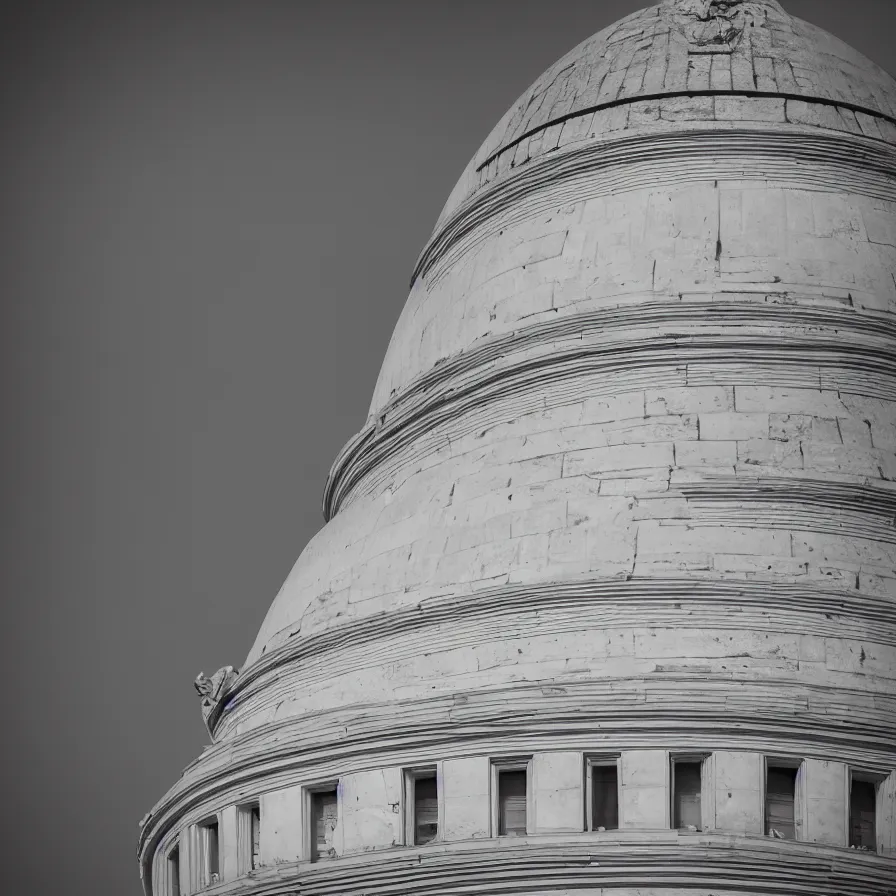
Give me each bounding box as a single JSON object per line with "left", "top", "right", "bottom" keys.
{"left": 411, "top": 128, "right": 896, "bottom": 288}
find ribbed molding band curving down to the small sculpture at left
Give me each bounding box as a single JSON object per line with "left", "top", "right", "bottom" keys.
{"left": 228, "top": 576, "right": 896, "bottom": 732}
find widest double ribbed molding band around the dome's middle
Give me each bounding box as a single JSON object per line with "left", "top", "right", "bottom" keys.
{"left": 323, "top": 312, "right": 896, "bottom": 521}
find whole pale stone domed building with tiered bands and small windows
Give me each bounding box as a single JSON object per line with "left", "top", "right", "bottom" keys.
{"left": 139, "top": 0, "right": 896, "bottom": 896}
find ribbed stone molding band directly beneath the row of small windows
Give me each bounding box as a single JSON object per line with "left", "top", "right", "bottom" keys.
{"left": 191, "top": 831, "right": 896, "bottom": 896}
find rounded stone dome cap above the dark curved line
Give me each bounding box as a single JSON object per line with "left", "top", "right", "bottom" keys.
{"left": 439, "top": 0, "right": 896, "bottom": 224}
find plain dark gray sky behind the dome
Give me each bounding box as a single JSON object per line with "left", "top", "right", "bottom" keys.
{"left": 0, "top": 0, "right": 896, "bottom": 896}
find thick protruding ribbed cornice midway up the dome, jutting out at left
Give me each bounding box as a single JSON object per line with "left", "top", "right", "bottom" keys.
{"left": 323, "top": 300, "right": 896, "bottom": 521}
